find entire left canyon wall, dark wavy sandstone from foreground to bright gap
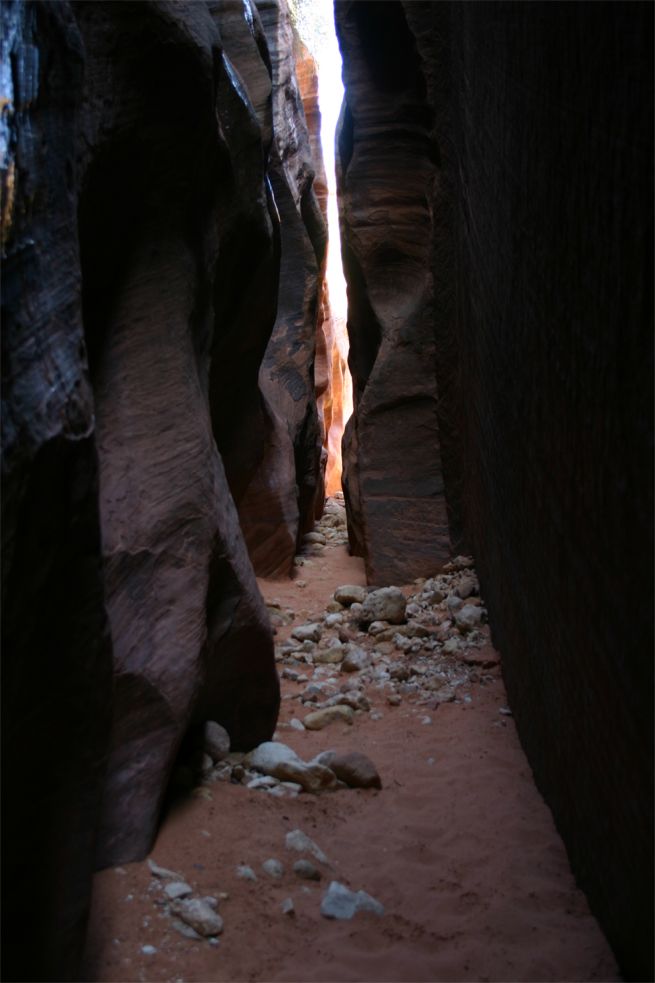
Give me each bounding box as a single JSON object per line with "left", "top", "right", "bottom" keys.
{"left": 0, "top": 0, "right": 325, "bottom": 980}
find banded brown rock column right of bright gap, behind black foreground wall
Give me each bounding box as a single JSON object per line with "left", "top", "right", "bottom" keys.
{"left": 337, "top": 3, "right": 450, "bottom": 585}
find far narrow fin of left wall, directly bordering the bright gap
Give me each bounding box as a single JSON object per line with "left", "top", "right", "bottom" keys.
{"left": 226, "top": 0, "right": 326, "bottom": 576}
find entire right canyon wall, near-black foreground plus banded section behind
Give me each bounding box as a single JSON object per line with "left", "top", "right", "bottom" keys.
{"left": 337, "top": 2, "right": 653, "bottom": 980}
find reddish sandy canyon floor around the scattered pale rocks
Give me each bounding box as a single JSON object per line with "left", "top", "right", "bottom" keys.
{"left": 85, "top": 504, "right": 621, "bottom": 983}
